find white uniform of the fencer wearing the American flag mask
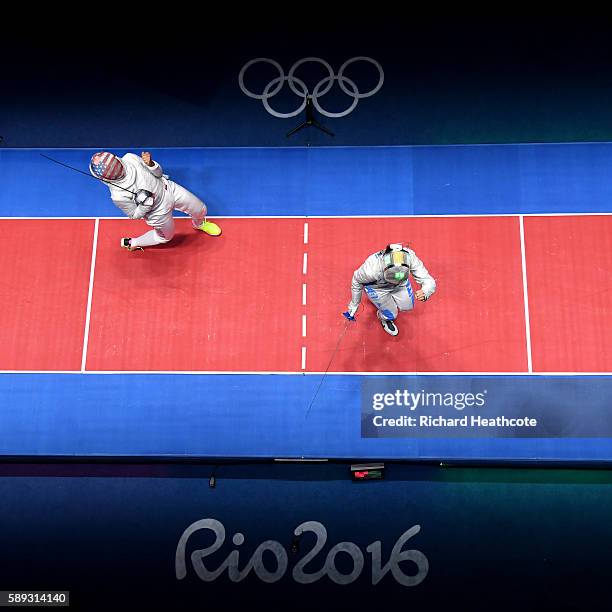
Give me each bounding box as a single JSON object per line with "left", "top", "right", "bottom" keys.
{"left": 107, "top": 153, "right": 207, "bottom": 247}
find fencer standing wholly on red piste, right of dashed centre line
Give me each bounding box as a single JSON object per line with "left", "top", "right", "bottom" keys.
{"left": 347, "top": 244, "right": 436, "bottom": 336}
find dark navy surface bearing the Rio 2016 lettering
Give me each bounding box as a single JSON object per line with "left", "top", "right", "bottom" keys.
{"left": 0, "top": 465, "right": 612, "bottom": 612}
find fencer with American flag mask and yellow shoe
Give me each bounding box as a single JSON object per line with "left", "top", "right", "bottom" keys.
{"left": 89, "top": 151, "right": 221, "bottom": 251}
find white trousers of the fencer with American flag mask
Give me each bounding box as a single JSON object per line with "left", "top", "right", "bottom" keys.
{"left": 130, "top": 181, "right": 207, "bottom": 247}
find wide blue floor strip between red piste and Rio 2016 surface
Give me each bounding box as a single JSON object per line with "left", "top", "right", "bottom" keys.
{"left": 0, "top": 374, "right": 612, "bottom": 464}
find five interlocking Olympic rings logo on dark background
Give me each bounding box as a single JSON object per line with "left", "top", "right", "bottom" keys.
{"left": 238, "top": 56, "right": 385, "bottom": 119}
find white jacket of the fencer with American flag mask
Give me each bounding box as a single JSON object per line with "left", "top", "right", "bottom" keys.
{"left": 106, "top": 153, "right": 174, "bottom": 220}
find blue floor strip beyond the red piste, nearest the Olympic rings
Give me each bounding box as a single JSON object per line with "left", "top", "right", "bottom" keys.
{"left": 0, "top": 143, "right": 612, "bottom": 217}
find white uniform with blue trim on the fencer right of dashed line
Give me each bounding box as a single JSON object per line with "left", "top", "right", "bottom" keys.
{"left": 349, "top": 247, "right": 436, "bottom": 321}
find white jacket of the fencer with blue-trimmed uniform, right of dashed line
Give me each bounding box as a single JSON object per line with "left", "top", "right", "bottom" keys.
{"left": 351, "top": 247, "right": 436, "bottom": 306}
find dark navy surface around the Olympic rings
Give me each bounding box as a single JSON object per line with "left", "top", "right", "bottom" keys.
{"left": 0, "top": 16, "right": 612, "bottom": 147}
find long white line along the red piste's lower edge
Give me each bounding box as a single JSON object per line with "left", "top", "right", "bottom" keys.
{"left": 0, "top": 370, "right": 612, "bottom": 378}
